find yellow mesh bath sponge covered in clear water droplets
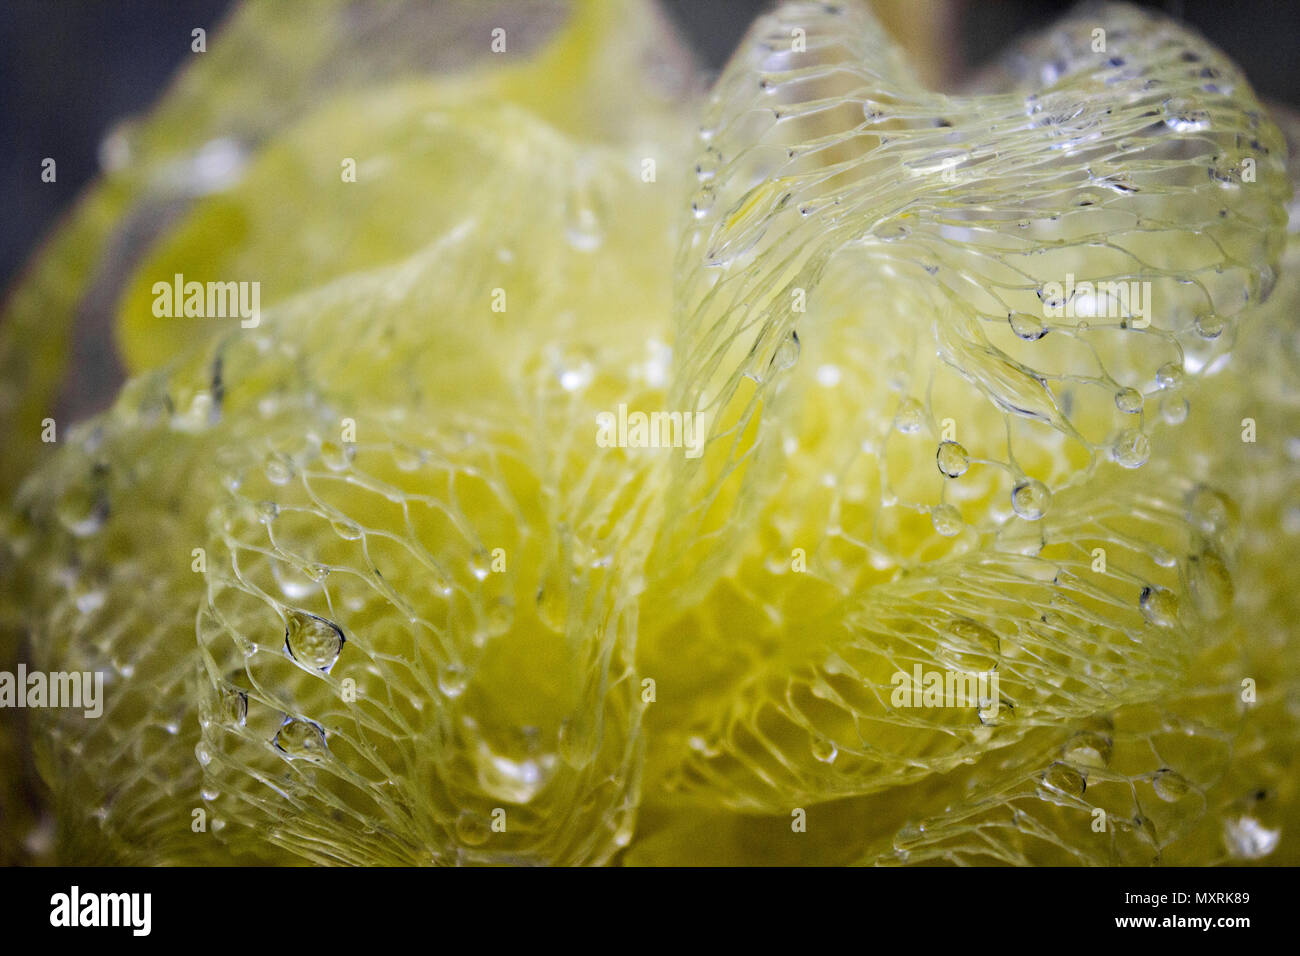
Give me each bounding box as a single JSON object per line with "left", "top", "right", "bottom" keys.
{"left": 4, "top": 3, "right": 1300, "bottom": 864}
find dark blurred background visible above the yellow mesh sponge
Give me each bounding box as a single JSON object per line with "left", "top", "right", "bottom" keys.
{"left": 0, "top": 0, "right": 1300, "bottom": 289}
